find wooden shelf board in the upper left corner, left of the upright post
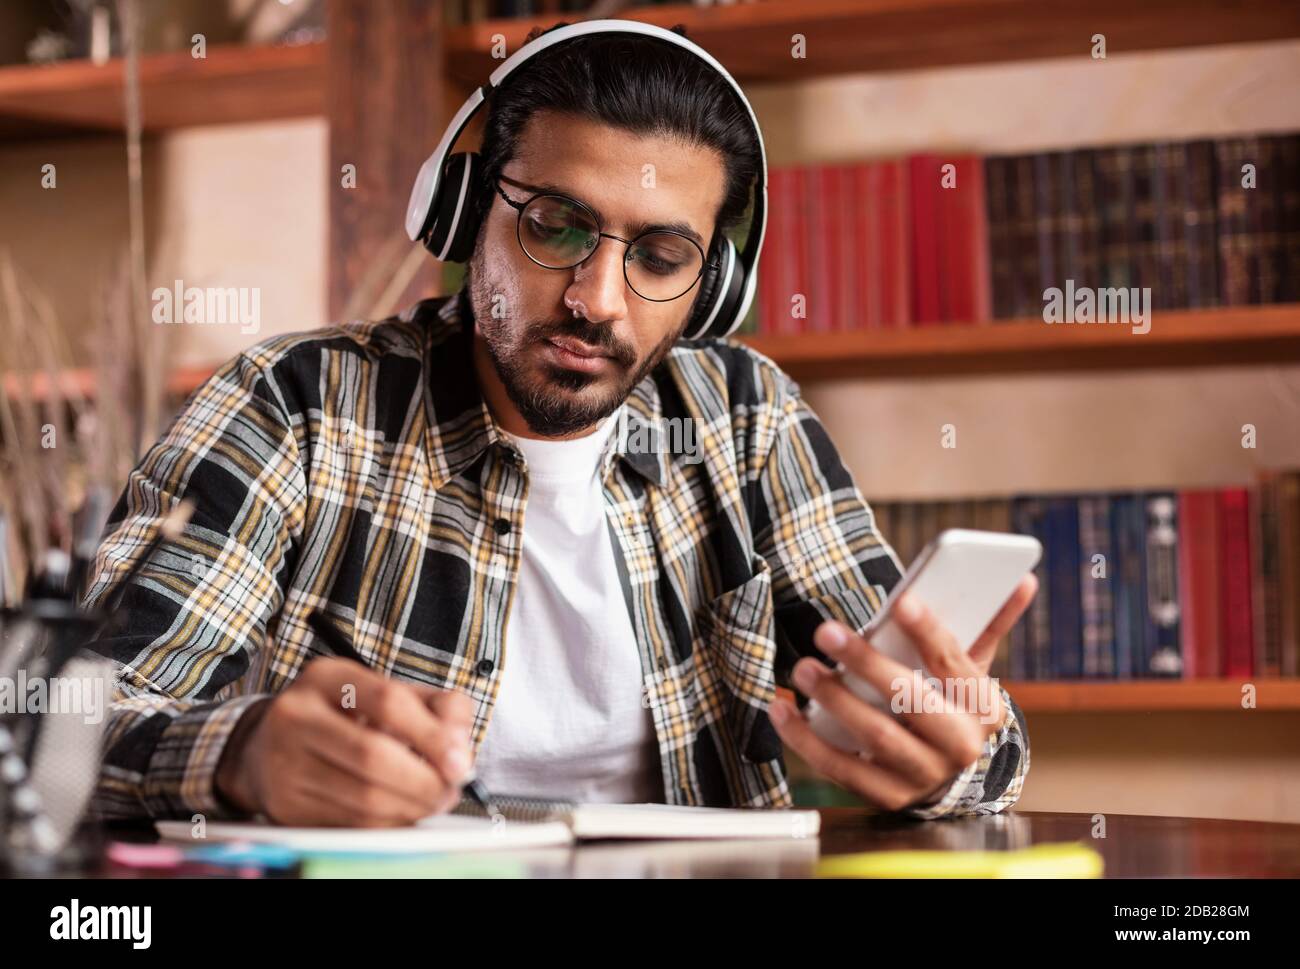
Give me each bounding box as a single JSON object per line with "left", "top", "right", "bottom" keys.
{"left": 0, "top": 43, "right": 325, "bottom": 138}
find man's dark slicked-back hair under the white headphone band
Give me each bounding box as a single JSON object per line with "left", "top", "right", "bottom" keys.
{"left": 477, "top": 22, "right": 761, "bottom": 249}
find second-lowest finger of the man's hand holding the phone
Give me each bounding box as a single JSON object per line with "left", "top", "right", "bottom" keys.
{"left": 794, "top": 659, "right": 952, "bottom": 791}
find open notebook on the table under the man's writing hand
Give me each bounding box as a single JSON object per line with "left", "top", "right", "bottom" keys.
{"left": 156, "top": 797, "right": 820, "bottom": 853}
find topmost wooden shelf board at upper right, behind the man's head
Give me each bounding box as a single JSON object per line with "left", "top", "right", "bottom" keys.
{"left": 446, "top": 0, "right": 1300, "bottom": 87}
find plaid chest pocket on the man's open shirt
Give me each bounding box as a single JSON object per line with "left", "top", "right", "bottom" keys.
{"left": 696, "top": 555, "right": 781, "bottom": 762}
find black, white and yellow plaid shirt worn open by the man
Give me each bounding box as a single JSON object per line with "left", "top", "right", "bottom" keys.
{"left": 85, "top": 293, "right": 1028, "bottom": 818}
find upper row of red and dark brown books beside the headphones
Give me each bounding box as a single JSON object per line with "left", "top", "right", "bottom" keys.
{"left": 741, "top": 134, "right": 1300, "bottom": 334}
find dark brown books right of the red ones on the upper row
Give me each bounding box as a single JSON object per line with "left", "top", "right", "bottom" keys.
{"left": 985, "top": 134, "right": 1300, "bottom": 317}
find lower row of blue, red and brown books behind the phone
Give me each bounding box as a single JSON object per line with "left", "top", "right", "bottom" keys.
{"left": 872, "top": 471, "right": 1300, "bottom": 680}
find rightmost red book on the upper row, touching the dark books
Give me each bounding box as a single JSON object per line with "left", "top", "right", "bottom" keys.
{"left": 937, "top": 155, "right": 993, "bottom": 323}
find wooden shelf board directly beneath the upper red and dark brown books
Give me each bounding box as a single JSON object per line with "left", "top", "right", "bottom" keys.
{"left": 735, "top": 303, "right": 1300, "bottom": 380}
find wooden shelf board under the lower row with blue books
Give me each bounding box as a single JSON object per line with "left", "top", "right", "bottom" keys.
{"left": 1002, "top": 679, "right": 1300, "bottom": 713}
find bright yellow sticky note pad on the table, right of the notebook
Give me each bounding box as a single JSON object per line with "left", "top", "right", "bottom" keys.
{"left": 816, "top": 842, "right": 1104, "bottom": 878}
